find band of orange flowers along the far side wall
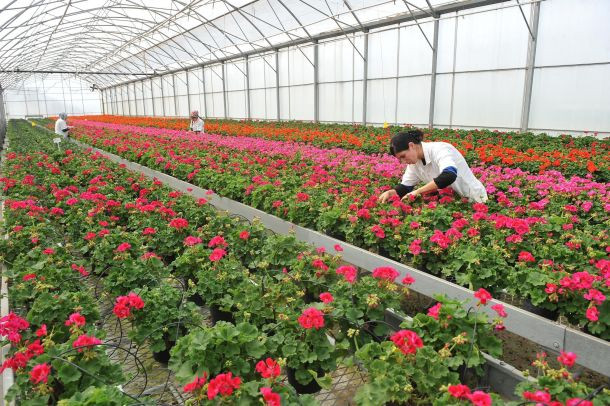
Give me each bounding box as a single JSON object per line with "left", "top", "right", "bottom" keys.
{"left": 64, "top": 116, "right": 610, "bottom": 182}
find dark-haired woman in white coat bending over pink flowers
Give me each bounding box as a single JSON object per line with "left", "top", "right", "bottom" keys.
{"left": 378, "top": 130, "right": 487, "bottom": 203}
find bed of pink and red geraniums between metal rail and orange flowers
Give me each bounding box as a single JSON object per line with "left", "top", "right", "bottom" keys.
{"left": 60, "top": 122, "right": 610, "bottom": 339}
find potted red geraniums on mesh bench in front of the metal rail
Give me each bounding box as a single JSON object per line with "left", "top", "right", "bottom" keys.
{"left": 0, "top": 123, "right": 607, "bottom": 405}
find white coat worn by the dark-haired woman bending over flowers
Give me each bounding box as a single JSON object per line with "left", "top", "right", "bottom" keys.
{"left": 400, "top": 142, "right": 487, "bottom": 203}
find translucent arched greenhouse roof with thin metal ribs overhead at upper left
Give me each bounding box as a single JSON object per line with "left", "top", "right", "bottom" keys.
{"left": 0, "top": 0, "right": 459, "bottom": 88}
